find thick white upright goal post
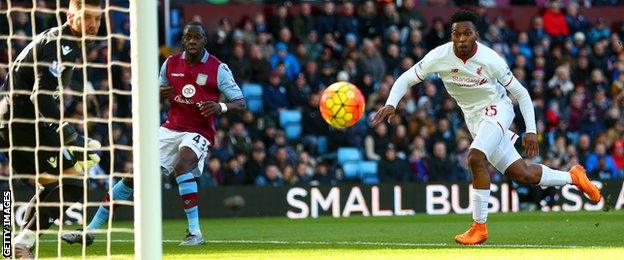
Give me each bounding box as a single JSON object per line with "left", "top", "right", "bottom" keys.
{"left": 130, "top": 0, "right": 162, "bottom": 260}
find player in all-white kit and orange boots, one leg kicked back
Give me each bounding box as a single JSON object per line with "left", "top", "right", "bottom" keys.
{"left": 373, "top": 11, "right": 602, "bottom": 245}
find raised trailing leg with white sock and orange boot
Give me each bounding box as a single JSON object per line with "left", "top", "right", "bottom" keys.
{"left": 505, "top": 160, "right": 602, "bottom": 202}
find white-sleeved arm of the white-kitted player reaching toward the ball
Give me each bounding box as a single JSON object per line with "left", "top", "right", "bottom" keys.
{"left": 371, "top": 68, "right": 421, "bottom": 125}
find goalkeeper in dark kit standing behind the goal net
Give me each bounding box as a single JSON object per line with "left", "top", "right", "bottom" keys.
{"left": 0, "top": 0, "right": 102, "bottom": 257}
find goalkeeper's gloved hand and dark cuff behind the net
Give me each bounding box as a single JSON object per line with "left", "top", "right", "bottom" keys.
{"left": 57, "top": 123, "right": 102, "bottom": 172}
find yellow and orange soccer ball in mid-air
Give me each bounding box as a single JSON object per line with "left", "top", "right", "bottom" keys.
{"left": 319, "top": 81, "right": 364, "bottom": 128}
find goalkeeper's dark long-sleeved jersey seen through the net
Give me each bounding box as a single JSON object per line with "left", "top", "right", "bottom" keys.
{"left": 0, "top": 25, "right": 81, "bottom": 174}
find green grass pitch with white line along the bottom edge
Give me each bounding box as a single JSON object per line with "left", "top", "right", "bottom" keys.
{"left": 29, "top": 211, "right": 624, "bottom": 260}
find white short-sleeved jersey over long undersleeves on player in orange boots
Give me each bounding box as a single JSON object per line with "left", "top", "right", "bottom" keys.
{"left": 412, "top": 42, "right": 513, "bottom": 121}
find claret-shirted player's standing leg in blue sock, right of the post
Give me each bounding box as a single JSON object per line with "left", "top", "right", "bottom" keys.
{"left": 173, "top": 146, "right": 204, "bottom": 246}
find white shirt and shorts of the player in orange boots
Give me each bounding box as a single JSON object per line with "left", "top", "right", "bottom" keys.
{"left": 386, "top": 42, "right": 535, "bottom": 173}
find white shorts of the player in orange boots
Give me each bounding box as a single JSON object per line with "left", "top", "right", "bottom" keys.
{"left": 466, "top": 96, "right": 522, "bottom": 174}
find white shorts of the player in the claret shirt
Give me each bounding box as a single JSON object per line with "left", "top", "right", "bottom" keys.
{"left": 158, "top": 127, "right": 210, "bottom": 177}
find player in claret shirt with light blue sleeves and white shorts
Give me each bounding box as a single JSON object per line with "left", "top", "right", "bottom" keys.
{"left": 62, "top": 22, "right": 246, "bottom": 246}
